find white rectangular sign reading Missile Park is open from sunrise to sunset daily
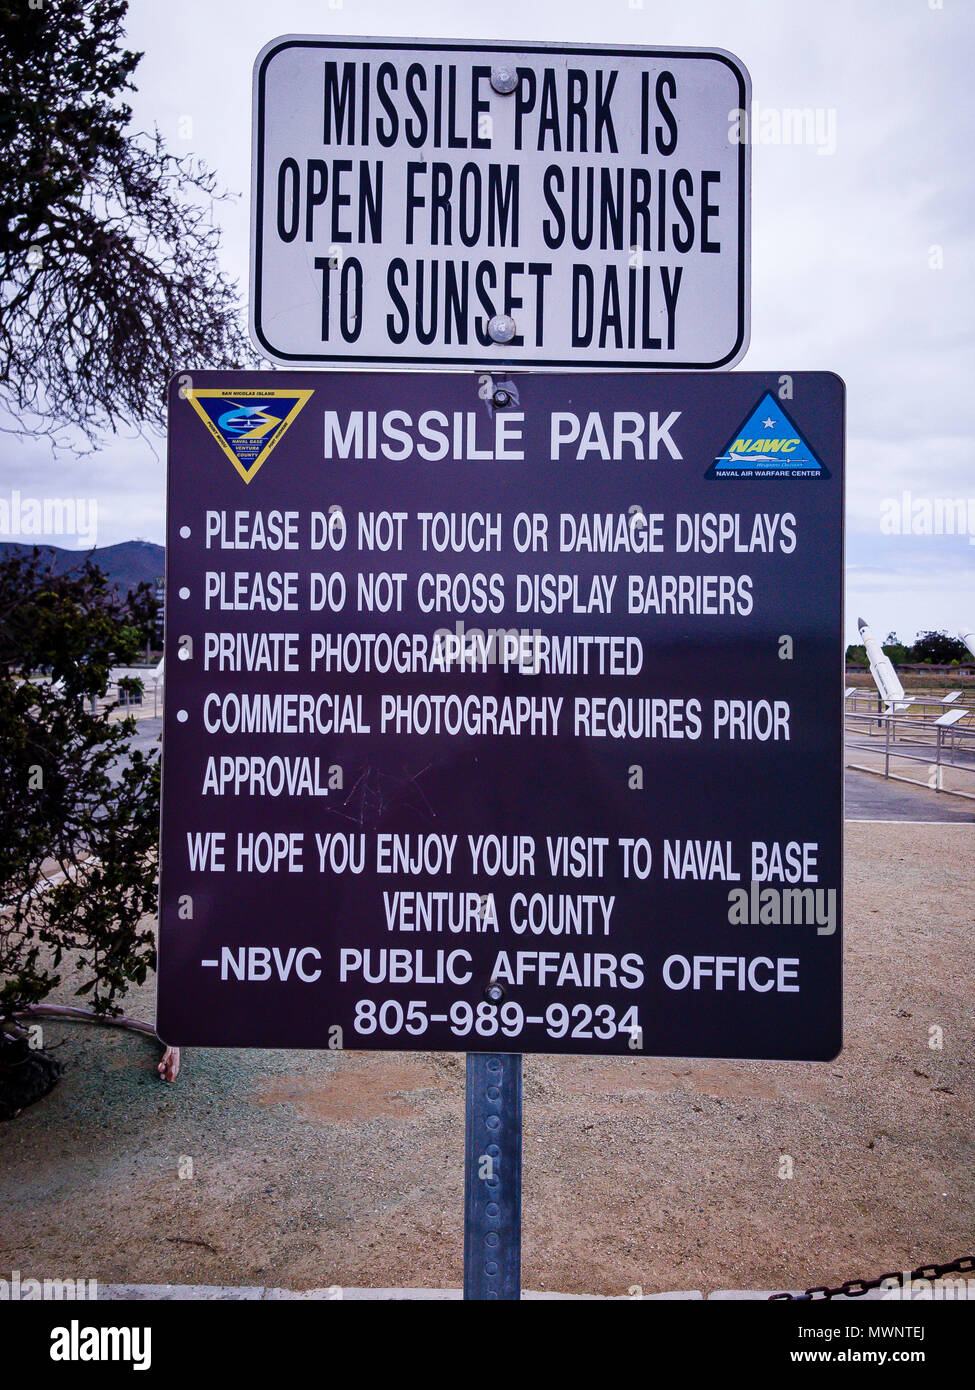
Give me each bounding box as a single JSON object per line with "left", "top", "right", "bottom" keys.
{"left": 250, "top": 36, "right": 751, "bottom": 370}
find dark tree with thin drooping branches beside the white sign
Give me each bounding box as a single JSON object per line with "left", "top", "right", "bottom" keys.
{"left": 0, "top": 0, "right": 256, "bottom": 441}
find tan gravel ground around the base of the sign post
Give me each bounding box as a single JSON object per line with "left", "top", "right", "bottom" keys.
{"left": 0, "top": 824, "right": 975, "bottom": 1294}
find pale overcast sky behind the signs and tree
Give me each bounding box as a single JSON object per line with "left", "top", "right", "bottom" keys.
{"left": 0, "top": 0, "right": 975, "bottom": 639}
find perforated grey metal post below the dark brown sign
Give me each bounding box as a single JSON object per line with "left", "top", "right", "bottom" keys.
{"left": 463, "top": 1052, "right": 522, "bottom": 1301}
